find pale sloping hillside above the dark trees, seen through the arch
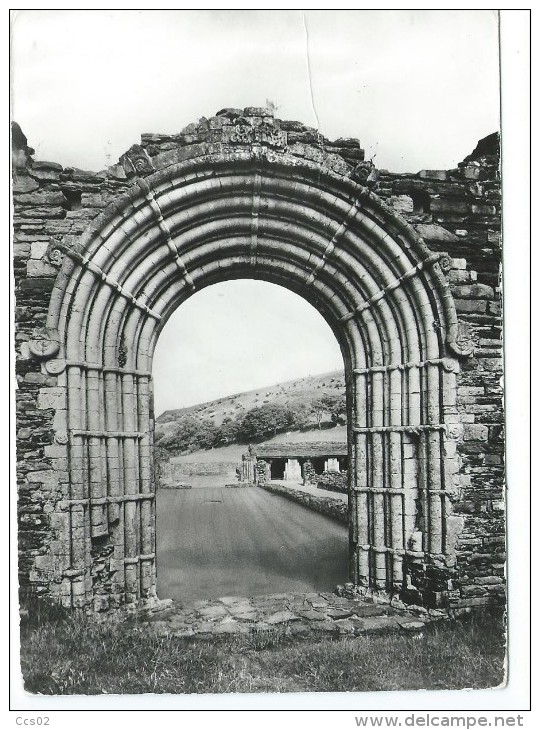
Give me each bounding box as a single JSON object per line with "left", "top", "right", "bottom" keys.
{"left": 156, "top": 370, "right": 345, "bottom": 434}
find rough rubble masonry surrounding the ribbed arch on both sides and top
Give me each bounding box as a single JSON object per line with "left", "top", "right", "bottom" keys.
{"left": 13, "top": 108, "right": 505, "bottom": 606}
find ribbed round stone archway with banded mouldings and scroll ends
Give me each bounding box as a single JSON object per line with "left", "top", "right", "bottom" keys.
{"left": 21, "top": 114, "right": 467, "bottom": 608}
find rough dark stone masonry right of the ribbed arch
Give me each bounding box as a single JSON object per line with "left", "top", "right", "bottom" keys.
{"left": 376, "top": 134, "right": 505, "bottom": 607}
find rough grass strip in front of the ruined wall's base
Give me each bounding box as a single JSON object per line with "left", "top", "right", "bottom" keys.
{"left": 17, "top": 600, "right": 505, "bottom": 695}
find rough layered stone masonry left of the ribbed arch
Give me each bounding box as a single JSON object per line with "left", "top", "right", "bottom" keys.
{"left": 13, "top": 126, "right": 133, "bottom": 594}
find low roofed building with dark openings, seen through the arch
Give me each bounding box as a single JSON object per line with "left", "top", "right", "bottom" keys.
{"left": 256, "top": 441, "right": 348, "bottom": 484}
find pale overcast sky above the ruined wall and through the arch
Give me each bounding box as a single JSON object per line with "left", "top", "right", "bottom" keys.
{"left": 12, "top": 10, "right": 499, "bottom": 413}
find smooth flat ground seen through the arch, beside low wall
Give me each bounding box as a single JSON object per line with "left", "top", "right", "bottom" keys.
{"left": 157, "top": 487, "right": 348, "bottom": 601}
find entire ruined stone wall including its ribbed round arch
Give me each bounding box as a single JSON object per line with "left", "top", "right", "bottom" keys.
{"left": 13, "top": 107, "right": 505, "bottom": 610}
